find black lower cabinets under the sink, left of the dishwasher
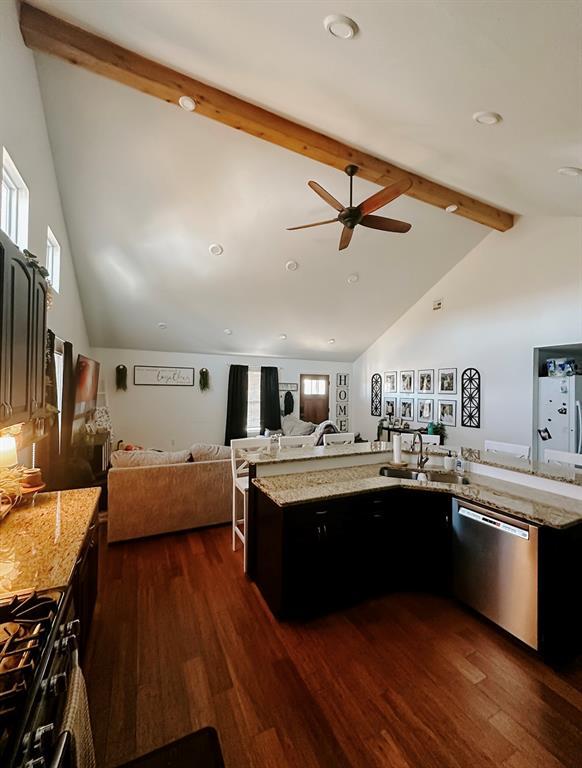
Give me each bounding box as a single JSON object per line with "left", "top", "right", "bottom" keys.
{"left": 252, "top": 488, "right": 451, "bottom": 617}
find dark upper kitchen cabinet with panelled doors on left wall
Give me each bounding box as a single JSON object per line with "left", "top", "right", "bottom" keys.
{"left": 0, "top": 233, "right": 47, "bottom": 427}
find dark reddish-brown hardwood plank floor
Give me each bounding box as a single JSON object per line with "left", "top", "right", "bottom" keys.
{"left": 87, "top": 528, "right": 582, "bottom": 768}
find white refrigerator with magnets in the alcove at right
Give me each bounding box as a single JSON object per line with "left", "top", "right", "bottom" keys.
{"left": 538, "top": 376, "right": 582, "bottom": 461}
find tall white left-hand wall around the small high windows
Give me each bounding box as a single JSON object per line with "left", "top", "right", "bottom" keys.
{"left": 0, "top": 0, "right": 89, "bottom": 352}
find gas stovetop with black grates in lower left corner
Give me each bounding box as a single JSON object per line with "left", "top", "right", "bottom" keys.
{"left": 0, "top": 590, "right": 63, "bottom": 764}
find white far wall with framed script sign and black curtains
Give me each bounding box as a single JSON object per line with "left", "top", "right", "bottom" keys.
{"left": 92, "top": 348, "right": 352, "bottom": 450}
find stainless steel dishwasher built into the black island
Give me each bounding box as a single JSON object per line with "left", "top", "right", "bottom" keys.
{"left": 453, "top": 499, "right": 538, "bottom": 649}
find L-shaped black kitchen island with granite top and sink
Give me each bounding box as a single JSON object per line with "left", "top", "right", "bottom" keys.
{"left": 248, "top": 456, "right": 582, "bottom": 659}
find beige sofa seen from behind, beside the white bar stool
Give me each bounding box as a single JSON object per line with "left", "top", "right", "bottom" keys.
{"left": 107, "top": 446, "right": 232, "bottom": 543}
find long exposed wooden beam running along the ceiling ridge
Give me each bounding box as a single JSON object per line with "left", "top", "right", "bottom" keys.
{"left": 20, "top": 2, "right": 513, "bottom": 232}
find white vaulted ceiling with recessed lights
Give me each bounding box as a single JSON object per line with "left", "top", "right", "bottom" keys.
{"left": 32, "top": 0, "right": 582, "bottom": 360}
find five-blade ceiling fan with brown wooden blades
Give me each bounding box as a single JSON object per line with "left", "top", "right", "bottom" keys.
{"left": 287, "top": 165, "right": 412, "bottom": 251}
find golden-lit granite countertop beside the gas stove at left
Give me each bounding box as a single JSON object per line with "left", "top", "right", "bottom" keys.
{"left": 0, "top": 488, "right": 101, "bottom": 597}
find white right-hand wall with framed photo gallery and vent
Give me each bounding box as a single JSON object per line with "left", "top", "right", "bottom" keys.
{"left": 351, "top": 217, "right": 582, "bottom": 447}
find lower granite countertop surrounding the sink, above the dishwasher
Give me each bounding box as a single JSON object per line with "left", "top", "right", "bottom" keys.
{"left": 253, "top": 464, "right": 582, "bottom": 528}
